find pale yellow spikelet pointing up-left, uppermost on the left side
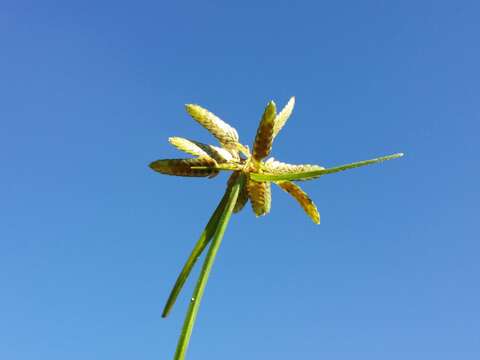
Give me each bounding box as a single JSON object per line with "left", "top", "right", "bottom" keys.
{"left": 185, "top": 104, "right": 238, "bottom": 150}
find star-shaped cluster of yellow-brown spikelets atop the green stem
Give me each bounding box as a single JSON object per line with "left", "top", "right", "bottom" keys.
{"left": 150, "top": 97, "right": 324, "bottom": 224}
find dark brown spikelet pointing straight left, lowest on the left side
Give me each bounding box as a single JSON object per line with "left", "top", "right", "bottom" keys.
{"left": 150, "top": 158, "right": 218, "bottom": 177}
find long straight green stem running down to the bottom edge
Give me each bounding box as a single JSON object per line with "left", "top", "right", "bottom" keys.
{"left": 174, "top": 176, "right": 244, "bottom": 360}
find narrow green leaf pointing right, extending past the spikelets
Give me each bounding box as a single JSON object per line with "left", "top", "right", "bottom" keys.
{"left": 250, "top": 153, "right": 403, "bottom": 181}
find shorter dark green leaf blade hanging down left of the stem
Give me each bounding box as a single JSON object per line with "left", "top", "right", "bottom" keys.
{"left": 162, "top": 189, "right": 228, "bottom": 317}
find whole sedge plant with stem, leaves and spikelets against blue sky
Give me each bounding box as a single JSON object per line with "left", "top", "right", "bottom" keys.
{"left": 150, "top": 97, "right": 403, "bottom": 360}
